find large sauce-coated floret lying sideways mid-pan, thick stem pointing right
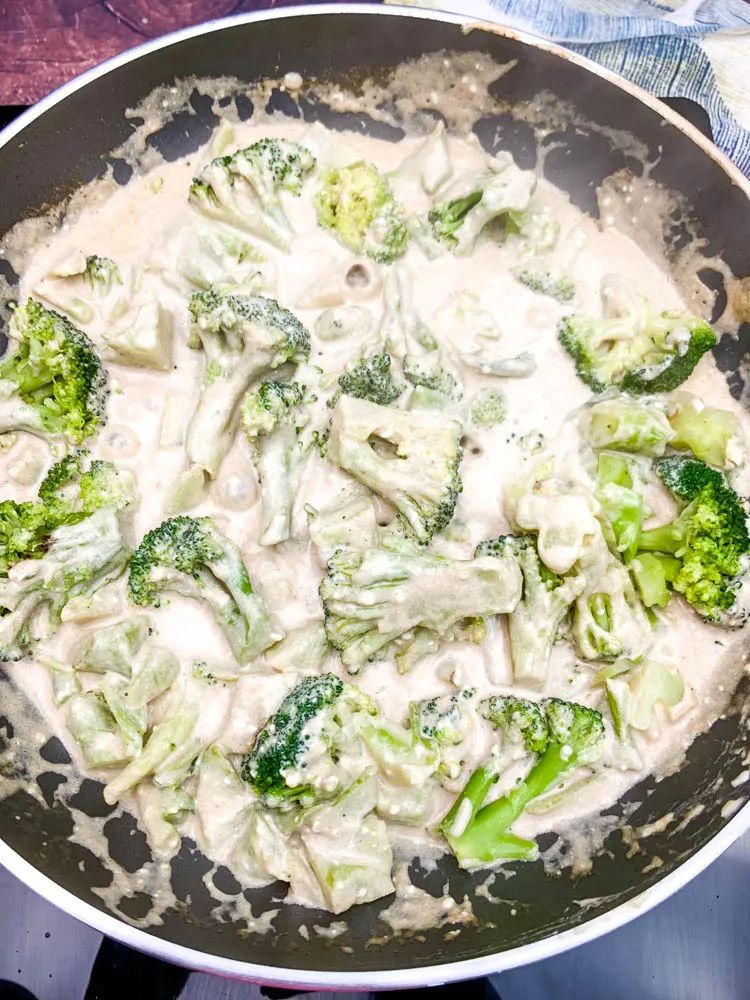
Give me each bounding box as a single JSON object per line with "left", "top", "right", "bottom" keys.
{"left": 320, "top": 536, "right": 521, "bottom": 672}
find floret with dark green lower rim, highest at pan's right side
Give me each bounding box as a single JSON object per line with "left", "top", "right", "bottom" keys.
{"left": 558, "top": 312, "right": 716, "bottom": 396}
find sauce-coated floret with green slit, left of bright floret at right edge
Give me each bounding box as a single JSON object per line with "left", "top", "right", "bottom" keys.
{"left": 573, "top": 536, "right": 651, "bottom": 660}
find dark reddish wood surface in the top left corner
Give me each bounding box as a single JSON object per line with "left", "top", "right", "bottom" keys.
{"left": 0, "top": 0, "right": 322, "bottom": 104}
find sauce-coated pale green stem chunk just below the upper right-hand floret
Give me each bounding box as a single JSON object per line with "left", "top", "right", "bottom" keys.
{"left": 580, "top": 398, "right": 675, "bottom": 456}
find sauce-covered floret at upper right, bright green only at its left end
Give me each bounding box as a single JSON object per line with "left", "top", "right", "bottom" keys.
{"left": 427, "top": 153, "right": 536, "bottom": 256}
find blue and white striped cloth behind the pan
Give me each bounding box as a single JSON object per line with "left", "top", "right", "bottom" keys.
{"left": 386, "top": 0, "right": 750, "bottom": 178}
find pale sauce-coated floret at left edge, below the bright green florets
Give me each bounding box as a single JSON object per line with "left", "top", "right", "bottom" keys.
{"left": 0, "top": 507, "right": 129, "bottom": 660}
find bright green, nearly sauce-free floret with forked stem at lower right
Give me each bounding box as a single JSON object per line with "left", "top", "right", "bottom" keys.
{"left": 441, "top": 698, "right": 604, "bottom": 868}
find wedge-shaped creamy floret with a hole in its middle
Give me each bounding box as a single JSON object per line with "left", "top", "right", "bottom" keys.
{"left": 328, "top": 396, "right": 462, "bottom": 542}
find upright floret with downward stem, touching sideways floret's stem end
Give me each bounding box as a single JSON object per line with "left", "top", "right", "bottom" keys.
{"left": 477, "top": 535, "right": 585, "bottom": 687}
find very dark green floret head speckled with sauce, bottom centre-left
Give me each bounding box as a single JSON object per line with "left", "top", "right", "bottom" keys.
{"left": 241, "top": 674, "right": 374, "bottom": 806}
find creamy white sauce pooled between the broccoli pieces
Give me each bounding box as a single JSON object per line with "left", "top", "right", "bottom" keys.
{"left": 0, "top": 68, "right": 747, "bottom": 927}
